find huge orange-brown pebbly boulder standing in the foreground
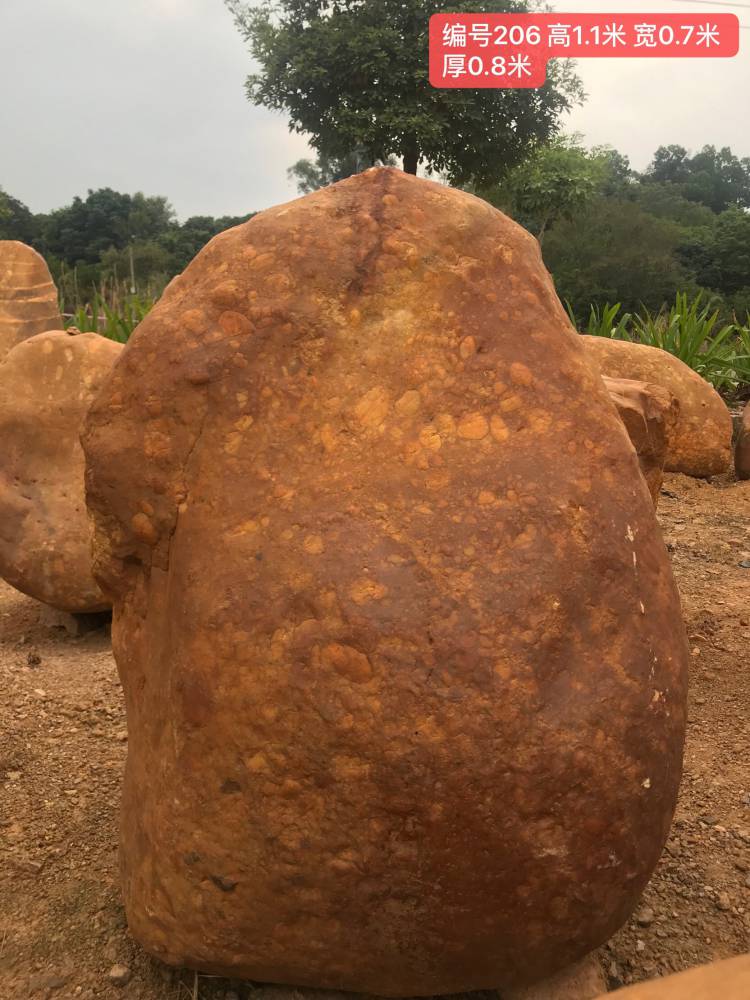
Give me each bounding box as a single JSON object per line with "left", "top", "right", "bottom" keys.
{"left": 84, "top": 169, "right": 686, "bottom": 996}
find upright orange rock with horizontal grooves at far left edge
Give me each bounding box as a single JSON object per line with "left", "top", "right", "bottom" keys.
{"left": 0, "top": 240, "right": 63, "bottom": 361}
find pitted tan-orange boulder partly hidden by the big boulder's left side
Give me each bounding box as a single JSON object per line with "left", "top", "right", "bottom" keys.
{"left": 0, "top": 330, "right": 122, "bottom": 613}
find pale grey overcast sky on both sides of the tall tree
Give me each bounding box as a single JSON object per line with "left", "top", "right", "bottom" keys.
{"left": 0, "top": 0, "right": 750, "bottom": 219}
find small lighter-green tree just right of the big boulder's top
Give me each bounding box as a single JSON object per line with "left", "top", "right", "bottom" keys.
{"left": 482, "top": 138, "right": 614, "bottom": 243}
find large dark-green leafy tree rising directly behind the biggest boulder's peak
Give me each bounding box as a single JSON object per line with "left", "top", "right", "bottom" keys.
{"left": 225, "top": 0, "right": 583, "bottom": 185}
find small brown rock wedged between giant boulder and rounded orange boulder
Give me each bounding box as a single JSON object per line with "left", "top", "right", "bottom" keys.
{"left": 603, "top": 375, "right": 680, "bottom": 507}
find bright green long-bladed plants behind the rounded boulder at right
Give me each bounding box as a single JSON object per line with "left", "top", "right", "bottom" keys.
{"left": 568, "top": 293, "right": 750, "bottom": 395}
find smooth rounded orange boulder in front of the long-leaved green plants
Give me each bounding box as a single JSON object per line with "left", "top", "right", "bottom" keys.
{"left": 583, "top": 337, "right": 732, "bottom": 478}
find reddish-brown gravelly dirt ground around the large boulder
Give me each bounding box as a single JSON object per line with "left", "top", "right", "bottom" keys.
{"left": 0, "top": 476, "right": 750, "bottom": 1000}
